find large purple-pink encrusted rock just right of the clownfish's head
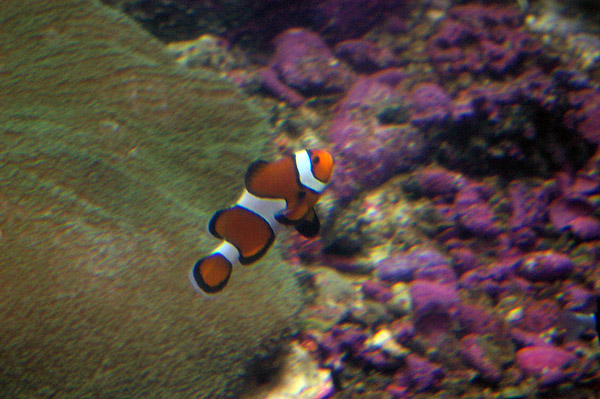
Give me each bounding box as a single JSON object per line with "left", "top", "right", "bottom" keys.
{"left": 327, "top": 70, "right": 427, "bottom": 199}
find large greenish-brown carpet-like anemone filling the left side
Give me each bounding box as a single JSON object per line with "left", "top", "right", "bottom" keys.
{"left": 0, "top": 0, "right": 301, "bottom": 398}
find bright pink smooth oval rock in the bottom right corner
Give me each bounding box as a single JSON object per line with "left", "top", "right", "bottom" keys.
{"left": 515, "top": 345, "right": 576, "bottom": 386}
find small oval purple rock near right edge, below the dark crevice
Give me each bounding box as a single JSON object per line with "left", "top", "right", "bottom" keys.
{"left": 518, "top": 251, "right": 574, "bottom": 282}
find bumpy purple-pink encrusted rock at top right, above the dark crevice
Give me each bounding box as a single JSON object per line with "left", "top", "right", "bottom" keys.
{"left": 428, "top": 4, "right": 540, "bottom": 75}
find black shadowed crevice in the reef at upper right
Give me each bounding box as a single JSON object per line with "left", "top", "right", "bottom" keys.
{"left": 435, "top": 104, "right": 596, "bottom": 180}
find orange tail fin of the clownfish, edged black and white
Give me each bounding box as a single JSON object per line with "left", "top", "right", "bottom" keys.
{"left": 189, "top": 253, "right": 233, "bottom": 295}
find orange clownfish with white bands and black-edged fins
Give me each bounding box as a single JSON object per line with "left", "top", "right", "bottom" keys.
{"left": 189, "top": 150, "right": 333, "bottom": 296}
